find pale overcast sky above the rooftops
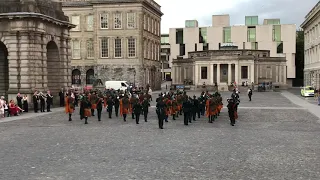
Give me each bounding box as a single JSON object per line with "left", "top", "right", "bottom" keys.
{"left": 155, "top": 0, "right": 319, "bottom": 33}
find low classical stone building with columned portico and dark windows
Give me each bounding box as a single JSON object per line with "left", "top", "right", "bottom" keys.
{"left": 172, "top": 49, "right": 287, "bottom": 91}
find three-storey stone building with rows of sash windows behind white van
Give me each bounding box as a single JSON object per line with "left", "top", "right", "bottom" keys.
{"left": 63, "top": 0, "right": 162, "bottom": 89}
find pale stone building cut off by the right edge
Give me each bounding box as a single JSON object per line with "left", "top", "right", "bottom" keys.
{"left": 301, "top": 2, "right": 320, "bottom": 89}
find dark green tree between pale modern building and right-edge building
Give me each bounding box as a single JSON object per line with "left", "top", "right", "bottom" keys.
{"left": 295, "top": 30, "right": 304, "bottom": 86}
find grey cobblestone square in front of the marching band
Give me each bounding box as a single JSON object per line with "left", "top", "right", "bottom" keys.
{"left": 0, "top": 93, "right": 320, "bottom": 180}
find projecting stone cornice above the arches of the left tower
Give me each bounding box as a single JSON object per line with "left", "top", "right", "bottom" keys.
{"left": 0, "top": 12, "right": 76, "bottom": 29}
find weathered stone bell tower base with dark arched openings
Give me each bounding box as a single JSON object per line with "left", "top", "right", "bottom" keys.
{"left": 0, "top": 0, "right": 75, "bottom": 102}
